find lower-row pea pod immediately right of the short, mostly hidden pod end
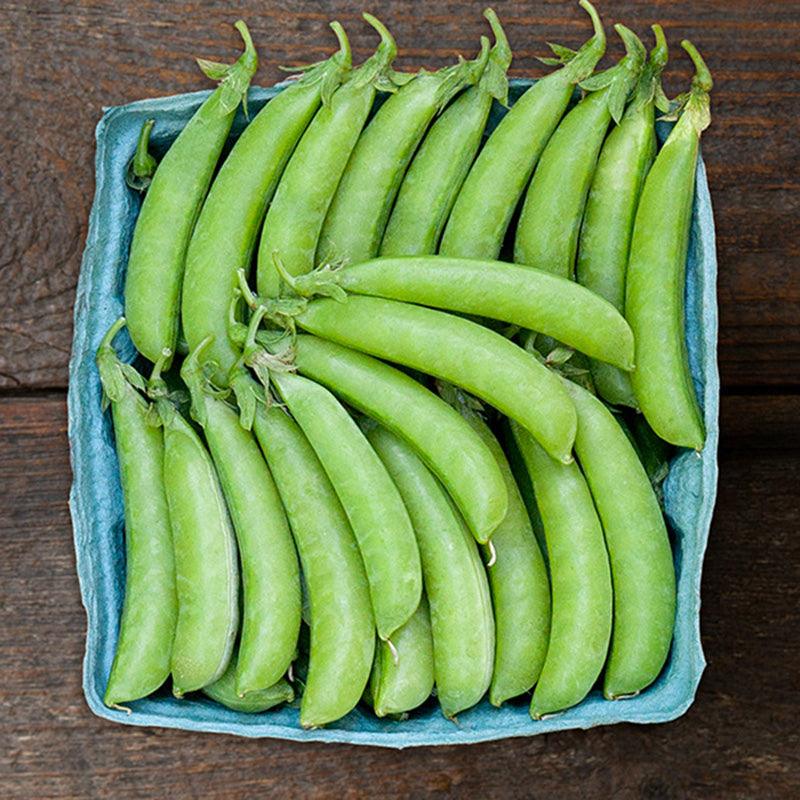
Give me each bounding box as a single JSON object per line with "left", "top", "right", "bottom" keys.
{"left": 367, "top": 426, "right": 494, "bottom": 718}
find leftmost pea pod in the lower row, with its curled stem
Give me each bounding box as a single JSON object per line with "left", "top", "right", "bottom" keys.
{"left": 97, "top": 319, "right": 178, "bottom": 706}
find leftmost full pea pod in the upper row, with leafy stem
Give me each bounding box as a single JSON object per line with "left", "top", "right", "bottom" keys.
{"left": 125, "top": 20, "right": 258, "bottom": 362}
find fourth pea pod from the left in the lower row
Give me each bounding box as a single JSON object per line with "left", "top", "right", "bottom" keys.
{"left": 254, "top": 406, "right": 375, "bottom": 728}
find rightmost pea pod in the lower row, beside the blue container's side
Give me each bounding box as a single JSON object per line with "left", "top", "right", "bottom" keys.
{"left": 564, "top": 381, "right": 675, "bottom": 700}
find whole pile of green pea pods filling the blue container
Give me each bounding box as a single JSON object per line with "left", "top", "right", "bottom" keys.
{"left": 97, "top": 0, "right": 712, "bottom": 727}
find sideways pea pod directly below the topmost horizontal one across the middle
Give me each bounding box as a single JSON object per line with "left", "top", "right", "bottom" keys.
{"left": 297, "top": 295, "right": 577, "bottom": 461}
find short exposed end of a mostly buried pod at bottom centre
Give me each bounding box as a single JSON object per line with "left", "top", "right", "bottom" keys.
{"left": 370, "top": 594, "right": 433, "bottom": 717}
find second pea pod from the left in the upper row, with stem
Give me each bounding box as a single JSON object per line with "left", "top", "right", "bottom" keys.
{"left": 181, "top": 22, "right": 350, "bottom": 386}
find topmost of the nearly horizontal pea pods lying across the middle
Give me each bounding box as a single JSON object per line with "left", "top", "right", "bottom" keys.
{"left": 336, "top": 256, "right": 633, "bottom": 369}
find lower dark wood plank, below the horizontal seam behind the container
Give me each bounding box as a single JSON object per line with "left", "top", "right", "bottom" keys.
{"left": 0, "top": 393, "right": 800, "bottom": 800}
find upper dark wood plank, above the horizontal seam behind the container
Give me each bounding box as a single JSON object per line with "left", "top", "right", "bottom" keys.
{"left": 0, "top": 0, "right": 800, "bottom": 390}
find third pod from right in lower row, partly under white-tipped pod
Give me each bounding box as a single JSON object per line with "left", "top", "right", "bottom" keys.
{"left": 454, "top": 412, "right": 550, "bottom": 706}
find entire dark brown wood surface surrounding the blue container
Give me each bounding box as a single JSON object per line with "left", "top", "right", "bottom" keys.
{"left": 0, "top": 0, "right": 800, "bottom": 800}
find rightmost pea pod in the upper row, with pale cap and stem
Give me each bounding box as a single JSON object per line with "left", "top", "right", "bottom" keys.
{"left": 625, "top": 41, "right": 713, "bottom": 450}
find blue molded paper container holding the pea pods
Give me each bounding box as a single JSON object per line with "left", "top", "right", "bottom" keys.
{"left": 69, "top": 80, "right": 719, "bottom": 748}
